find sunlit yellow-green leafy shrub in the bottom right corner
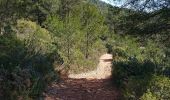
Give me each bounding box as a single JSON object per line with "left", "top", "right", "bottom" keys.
{"left": 141, "top": 76, "right": 170, "bottom": 100}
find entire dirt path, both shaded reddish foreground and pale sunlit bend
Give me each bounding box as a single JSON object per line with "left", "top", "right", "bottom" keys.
{"left": 45, "top": 54, "right": 121, "bottom": 100}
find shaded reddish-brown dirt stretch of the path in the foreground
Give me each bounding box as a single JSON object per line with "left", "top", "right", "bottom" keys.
{"left": 45, "top": 79, "right": 121, "bottom": 100}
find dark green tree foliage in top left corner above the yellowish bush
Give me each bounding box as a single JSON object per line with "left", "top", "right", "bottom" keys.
{"left": 0, "top": 0, "right": 60, "bottom": 31}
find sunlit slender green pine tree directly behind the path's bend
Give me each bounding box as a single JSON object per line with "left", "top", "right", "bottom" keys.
{"left": 81, "top": 4, "right": 104, "bottom": 59}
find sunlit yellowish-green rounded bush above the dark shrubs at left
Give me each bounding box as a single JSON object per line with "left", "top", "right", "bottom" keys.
{"left": 17, "top": 20, "right": 55, "bottom": 54}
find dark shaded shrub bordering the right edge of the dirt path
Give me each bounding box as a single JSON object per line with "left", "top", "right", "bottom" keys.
{"left": 113, "top": 59, "right": 154, "bottom": 99}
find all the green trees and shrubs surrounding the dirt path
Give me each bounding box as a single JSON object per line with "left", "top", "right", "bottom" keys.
{"left": 0, "top": 0, "right": 170, "bottom": 100}
